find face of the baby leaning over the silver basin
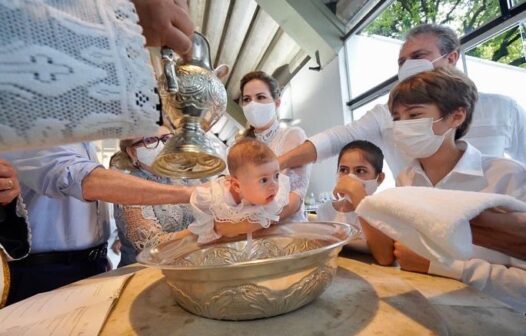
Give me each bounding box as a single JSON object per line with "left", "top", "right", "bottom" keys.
{"left": 236, "top": 160, "right": 279, "bottom": 205}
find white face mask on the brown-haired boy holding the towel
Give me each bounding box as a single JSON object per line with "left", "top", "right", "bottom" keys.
{"left": 393, "top": 118, "right": 454, "bottom": 159}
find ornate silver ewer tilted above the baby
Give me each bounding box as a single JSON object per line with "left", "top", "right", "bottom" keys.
{"left": 152, "top": 32, "right": 227, "bottom": 178}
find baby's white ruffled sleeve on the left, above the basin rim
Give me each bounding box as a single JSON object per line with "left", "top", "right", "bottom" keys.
{"left": 188, "top": 187, "right": 221, "bottom": 244}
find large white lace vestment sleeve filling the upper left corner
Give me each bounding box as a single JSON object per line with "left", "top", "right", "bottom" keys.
{"left": 0, "top": 0, "right": 159, "bottom": 151}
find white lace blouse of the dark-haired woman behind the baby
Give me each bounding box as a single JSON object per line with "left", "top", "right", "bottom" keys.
{"left": 255, "top": 120, "right": 312, "bottom": 221}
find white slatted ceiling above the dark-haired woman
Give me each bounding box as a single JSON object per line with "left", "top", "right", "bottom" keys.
{"left": 189, "top": 0, "right": 307, "bottom": 99}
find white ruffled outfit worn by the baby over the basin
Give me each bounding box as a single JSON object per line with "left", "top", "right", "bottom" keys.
{"left": 188, "top": 174, "right": 290, "bottom": 244}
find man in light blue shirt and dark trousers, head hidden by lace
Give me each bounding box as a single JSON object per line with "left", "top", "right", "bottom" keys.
{"left": 1, "top": 143, "right": 196, "bottom": 304}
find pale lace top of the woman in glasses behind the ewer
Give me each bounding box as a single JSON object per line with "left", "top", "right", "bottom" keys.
{"left": 114, "top": 169, "right": 196, "bottom": 251}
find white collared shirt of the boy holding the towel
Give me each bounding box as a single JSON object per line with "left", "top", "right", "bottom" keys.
{"left": 397, "top": 140, "right": 526, "bottom": 313}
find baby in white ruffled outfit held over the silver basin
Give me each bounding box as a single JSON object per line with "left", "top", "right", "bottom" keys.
{"left": 188, "top": 139, "right": 290, "bottom": 244}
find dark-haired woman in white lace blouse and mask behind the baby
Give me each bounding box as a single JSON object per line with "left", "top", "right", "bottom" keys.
{"left": 240, "top": 71, "right": 310, "bottom": 221}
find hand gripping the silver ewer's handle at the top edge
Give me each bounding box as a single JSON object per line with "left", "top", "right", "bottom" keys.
{"left": 132, "top": 0, "right": 194, "bottom": 57}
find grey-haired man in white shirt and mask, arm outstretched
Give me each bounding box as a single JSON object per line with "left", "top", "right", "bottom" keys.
{"left": 279, "top": 24, "right": 526, "bottom": 177}
